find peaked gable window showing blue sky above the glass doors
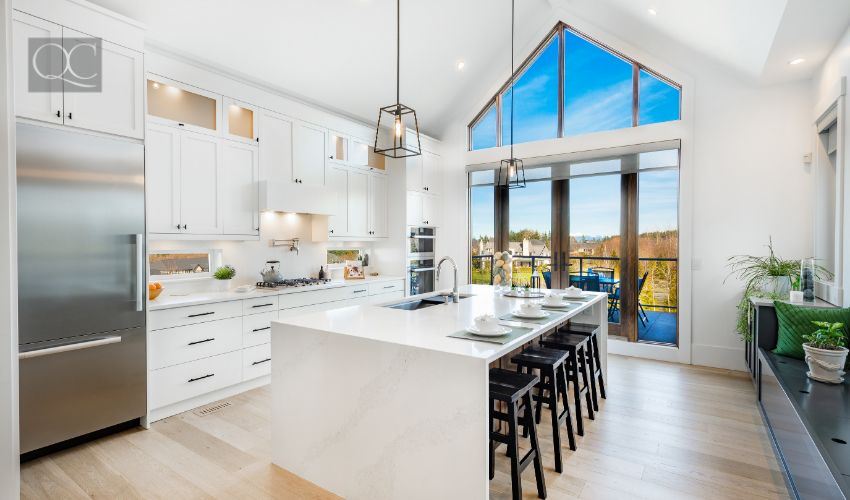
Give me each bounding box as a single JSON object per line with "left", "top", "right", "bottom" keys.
{"left": 469, "top": 23, "right": 681, "bottom": 150}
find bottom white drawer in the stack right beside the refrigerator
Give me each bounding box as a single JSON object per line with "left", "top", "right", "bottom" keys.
{"left": 150, "top": 351, "right": 242, "bottom": 408}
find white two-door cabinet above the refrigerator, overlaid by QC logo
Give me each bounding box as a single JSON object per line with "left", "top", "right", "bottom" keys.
{"left": 12, "top": 11, "right": 144, "bottom": 138}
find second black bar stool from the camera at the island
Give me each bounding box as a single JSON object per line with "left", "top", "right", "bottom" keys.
{"left": 511, "top": 347, "right": 576, "bottom": 472}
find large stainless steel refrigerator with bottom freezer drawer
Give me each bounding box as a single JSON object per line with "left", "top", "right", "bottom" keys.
{"left": 16, "top": 123, "right": 147, "bottom": 454}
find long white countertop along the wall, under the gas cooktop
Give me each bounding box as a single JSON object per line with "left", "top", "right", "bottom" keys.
{"left": 148, "top": 275, "right": 404, "bottom": 311}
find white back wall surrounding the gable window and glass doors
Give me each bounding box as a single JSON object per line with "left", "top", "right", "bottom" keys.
{"left": 440, "top": 8, "right": 813, "bottom": 369}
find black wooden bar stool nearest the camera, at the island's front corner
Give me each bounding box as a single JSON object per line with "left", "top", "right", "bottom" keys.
{"left": 490, "top": 368, "right": 546, "bottom": 500}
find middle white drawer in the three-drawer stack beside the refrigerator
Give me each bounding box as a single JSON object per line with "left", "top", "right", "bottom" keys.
{"left": 150, "top": 318, "right": 242, "bottom": 369}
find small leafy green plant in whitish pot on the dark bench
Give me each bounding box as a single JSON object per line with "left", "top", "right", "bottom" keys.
{"left": 803, "top": 321, "right": 847, "bottom": 384}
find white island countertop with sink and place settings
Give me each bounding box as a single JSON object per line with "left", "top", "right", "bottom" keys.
{"left": 272, "top": 285, "right": 607, "bottom": 362}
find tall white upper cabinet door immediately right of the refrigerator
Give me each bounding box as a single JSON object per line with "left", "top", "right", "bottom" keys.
{"left": 145, "top": 124, "right": 181, "bottom": 233}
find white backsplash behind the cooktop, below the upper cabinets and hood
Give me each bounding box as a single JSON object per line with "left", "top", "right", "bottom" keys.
{"left": 148, "top": 212, "right": 380, "bottom": 290}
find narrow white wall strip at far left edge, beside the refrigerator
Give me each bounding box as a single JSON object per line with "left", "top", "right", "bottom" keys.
{"left": 0, "top": 0, "right": 20, "bottom": 498}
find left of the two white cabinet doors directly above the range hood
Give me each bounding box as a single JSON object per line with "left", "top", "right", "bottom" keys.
{"left": 260, "top": 111, "right": 295, "bottom": 182}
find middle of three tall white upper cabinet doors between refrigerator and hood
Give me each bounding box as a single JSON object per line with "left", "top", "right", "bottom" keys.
{"left": 180, "top": 130, "right": 221, "bottom": 234}
